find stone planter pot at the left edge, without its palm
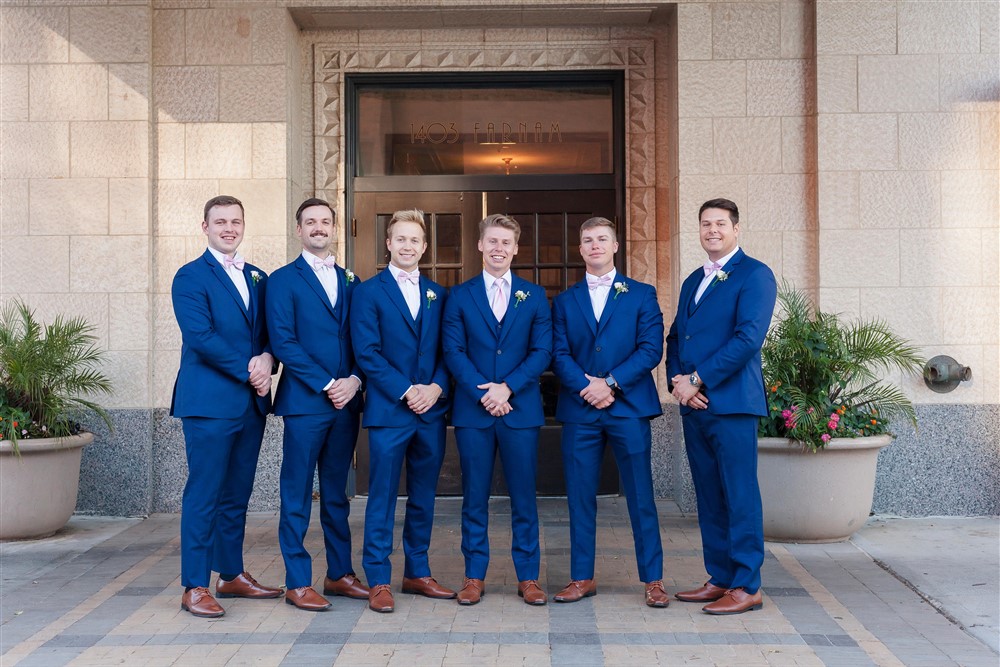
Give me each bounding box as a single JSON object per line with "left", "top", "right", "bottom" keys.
{"left": 0, "top": 433, "right": 94, "bottom": 540}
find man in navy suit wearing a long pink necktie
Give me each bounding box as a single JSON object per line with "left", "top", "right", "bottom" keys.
{"left": 442, "top": 214, "right": 552, "bottom": 605}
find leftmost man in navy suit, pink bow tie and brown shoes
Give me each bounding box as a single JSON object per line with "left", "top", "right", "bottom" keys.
{"left": 170, "top": 195, "right": 281, "bottom": 617}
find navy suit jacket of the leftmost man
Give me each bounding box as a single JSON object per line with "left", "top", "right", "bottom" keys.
{"left": 170, "top": 249, "right": 271, "bottom": 419}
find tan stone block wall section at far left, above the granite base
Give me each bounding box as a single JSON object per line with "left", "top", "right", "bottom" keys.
{"left": 0, "top": 3, "right": 152, "bottom": 407}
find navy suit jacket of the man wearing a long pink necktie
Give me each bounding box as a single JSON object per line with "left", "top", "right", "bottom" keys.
{"left": 442, "top": 274, "right": 552, "bottom": 428}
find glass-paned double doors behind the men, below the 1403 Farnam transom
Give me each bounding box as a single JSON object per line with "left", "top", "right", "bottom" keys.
{"left": 352, "top": 190, "right": 619, "bottom": 495}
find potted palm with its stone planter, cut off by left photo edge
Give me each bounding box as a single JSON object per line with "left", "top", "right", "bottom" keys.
{"left": 0, "top": 300, "right": 111, "bottom": 539}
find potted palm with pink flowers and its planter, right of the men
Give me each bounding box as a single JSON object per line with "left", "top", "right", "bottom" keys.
{"left": 757, "top": 285, "right": 924, "bottom": 542}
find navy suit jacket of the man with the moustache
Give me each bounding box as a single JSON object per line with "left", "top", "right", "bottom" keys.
{"left": 267, "top": 255, "right": 364, "bottom": 416}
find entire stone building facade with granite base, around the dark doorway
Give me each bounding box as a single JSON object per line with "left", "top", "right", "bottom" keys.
{"left": 0, "top": 0, "right": 1000, "bottom": 515}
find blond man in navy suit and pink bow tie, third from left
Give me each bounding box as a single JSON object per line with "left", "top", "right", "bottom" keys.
{"left": 351, "top": 210, "right": 455, "bottom": 613}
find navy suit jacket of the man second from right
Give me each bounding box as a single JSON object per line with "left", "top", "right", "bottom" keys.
{"left": 552, "top": 274, "right": 663, "bottom": 424}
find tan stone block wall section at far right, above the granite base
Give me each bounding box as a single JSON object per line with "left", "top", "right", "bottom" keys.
{"left": 816, "top": 0, "right": 1000, "bottom": 403}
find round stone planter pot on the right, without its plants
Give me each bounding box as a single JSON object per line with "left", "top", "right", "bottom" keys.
{"left": 757, "top": 435, "right": 892, "bottom": 542}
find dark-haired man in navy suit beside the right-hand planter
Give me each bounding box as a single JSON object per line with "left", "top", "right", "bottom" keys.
{"left": 667, "top": 199, "right": 777, "bottom": 615}
